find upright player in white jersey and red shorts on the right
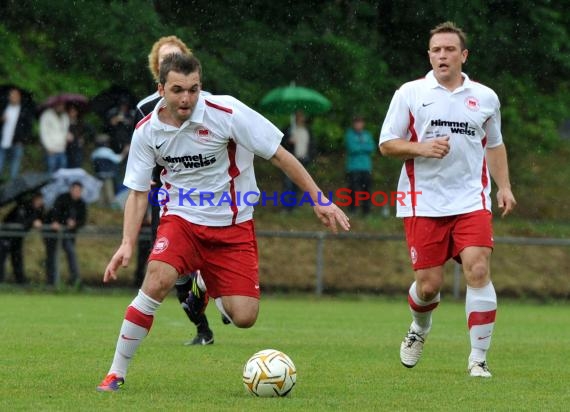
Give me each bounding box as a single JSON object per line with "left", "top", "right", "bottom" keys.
{"left": 379, "top": 22, "right": 516, "bottom": 377}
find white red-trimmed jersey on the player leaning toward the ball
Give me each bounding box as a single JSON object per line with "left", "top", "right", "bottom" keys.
{"left": 124, "top": 95, "right": 283, "bottom": 226}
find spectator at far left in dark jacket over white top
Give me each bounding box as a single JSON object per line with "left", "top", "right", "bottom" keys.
{"left": 0, "top": 87, "right": 34, "bottom": 179}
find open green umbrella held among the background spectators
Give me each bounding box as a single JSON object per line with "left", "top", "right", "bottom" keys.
{"left": 260, "top": 86, "right": 332, "bottom": 115}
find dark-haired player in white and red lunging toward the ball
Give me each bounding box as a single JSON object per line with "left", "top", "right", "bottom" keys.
{"left": 97, "top": 54, "right": 350, "bottom": 391}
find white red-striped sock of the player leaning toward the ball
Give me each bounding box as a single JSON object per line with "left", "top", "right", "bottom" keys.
{"left": 109, "top": 290, "right": 160, "bottom": 378}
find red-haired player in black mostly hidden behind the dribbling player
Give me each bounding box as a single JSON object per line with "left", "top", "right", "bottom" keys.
{"left": 135, "top": 36, "right": 217, "bottom": 345}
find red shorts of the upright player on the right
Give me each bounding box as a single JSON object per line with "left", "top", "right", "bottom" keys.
{"left": 404, "top": 210, "right": 493, "bottom": 270}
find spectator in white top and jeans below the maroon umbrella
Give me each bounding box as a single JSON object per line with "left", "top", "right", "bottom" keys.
{"left": 40, "top": 101, "right": 69, "bottom": 174}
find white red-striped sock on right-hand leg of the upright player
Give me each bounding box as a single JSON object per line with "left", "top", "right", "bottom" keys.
{"left": 465, "top": 282, "right": 497, "bottom": 362}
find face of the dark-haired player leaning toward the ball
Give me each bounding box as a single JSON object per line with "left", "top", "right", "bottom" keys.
{"left": 158, "top": 71, "right": 202, "bottom": 127}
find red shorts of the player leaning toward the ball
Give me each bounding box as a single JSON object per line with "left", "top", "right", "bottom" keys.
{"left": 148, "top": 215, "right": 259, "bottom": 298}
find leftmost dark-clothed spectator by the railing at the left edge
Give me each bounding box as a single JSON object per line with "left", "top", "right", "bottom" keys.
{"left": 0, "top": 193, "right": 44, "bottom": 284}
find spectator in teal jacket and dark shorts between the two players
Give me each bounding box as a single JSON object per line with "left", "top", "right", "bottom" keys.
{"left": 344, "top": 115, "right": 376, "bottom": 216}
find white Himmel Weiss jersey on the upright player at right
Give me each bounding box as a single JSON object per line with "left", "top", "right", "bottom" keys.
{"left": 380, "top": 71, "right": 503, "bottom": 217}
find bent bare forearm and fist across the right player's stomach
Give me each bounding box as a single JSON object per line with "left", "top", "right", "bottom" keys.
{"left": 380, "top": 136, "right": 451, "bottom": 159}
